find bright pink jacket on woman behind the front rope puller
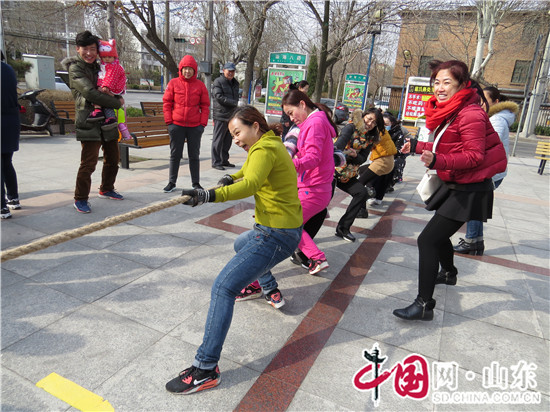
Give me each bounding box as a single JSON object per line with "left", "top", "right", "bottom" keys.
{"left": 293, "top": 110, "right": 336, "bottom": 192}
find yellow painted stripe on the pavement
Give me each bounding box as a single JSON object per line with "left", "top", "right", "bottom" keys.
{"left": 36, "top": 373, "right": 114, "bottom": 412}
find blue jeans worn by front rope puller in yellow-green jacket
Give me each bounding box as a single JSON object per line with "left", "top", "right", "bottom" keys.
{"left": 193, "top": 224, "right": 302, "bottom": 369}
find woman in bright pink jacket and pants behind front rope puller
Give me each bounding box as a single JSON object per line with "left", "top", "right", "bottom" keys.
{"left": 282, "top": 90, "right": 338, "bottom": 275}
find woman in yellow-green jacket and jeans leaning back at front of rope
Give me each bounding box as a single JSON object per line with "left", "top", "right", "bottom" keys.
{"left": 166, "top": 106, "right": 302, "bottom": 394}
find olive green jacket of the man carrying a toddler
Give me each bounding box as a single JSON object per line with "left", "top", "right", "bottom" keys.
{"left": 61, "top": 55, "right": 121, "bottom": 142}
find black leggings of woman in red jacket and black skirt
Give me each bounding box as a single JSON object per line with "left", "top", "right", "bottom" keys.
{"left": 417, "top": 213, "right": 464, "bottom": 302}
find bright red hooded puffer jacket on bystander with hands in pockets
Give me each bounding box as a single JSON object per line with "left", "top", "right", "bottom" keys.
{"left": 162, "top": 55, "right": 210, "bottom": 127}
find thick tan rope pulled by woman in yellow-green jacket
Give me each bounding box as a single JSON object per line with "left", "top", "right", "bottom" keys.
{"left": 0, "top": 185, "right": 221, "bottom": 262}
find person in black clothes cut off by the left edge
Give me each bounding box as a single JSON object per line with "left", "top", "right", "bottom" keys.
{"left": 2, "top": 53, "right": 21, "bottom": 219}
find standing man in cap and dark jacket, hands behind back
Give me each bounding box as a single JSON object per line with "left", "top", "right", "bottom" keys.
{"left": 212, "top": 62, "right": 239, "bottom": 170}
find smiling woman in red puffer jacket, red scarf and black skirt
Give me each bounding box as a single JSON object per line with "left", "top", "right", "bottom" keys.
{"left": 393, "top": 60, "right": 507, "bottom": 320}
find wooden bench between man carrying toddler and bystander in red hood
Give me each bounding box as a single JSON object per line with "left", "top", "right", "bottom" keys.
{"left": 118, "top": 116, "right": 170, "bottom": 169}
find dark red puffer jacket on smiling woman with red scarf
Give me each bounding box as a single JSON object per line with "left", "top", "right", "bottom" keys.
{"left": 416, "top": 99, "right": 507, "bottom": 184}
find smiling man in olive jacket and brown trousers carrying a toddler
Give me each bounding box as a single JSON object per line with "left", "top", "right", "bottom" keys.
{"left": 61, "top": 30, "right": 124, "bottom": 213}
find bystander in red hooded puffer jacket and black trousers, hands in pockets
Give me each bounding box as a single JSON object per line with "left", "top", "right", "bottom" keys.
{"left": 162, "top": 55, "right": 210, "bottom": 193}
